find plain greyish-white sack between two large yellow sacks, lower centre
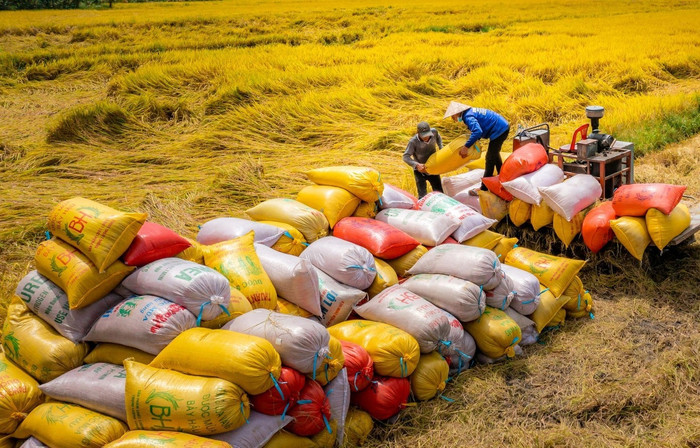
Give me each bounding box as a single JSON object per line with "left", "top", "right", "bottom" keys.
{"left": 222, "top": 308, "right": 330, "bottom": 374}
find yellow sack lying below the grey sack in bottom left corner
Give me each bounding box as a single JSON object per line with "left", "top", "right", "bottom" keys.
{"left": 12, "top": 402, "right": 127, "bottom": 448}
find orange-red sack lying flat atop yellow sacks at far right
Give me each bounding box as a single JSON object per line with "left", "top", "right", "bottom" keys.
{"left": 612, "top": 184, "right": 687, "bottom": 216}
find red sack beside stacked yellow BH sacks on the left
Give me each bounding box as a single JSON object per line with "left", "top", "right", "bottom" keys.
{"left": 122, "top": 221, "right": 192, "bottom": 266}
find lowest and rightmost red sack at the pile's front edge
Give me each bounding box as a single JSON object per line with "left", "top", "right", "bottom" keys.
{"left": 350, "top": 376, "right": 411, "bottom": 420}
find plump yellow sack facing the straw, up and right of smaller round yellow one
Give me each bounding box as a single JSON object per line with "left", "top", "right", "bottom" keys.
{"left": 464, "top": 306, "right": 522, "bottom": 358}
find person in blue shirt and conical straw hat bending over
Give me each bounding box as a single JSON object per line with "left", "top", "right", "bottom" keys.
{"left": 443, "top": 101, "right": 510, "bottom": 195}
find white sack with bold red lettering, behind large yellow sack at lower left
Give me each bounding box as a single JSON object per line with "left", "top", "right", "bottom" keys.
{"left": 85, "top": 295, "right": 197, "bottom": 355}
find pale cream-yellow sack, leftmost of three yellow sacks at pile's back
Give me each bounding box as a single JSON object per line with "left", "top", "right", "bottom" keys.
{"left": 246, "top": 198, "right": 328, "bottom": 243}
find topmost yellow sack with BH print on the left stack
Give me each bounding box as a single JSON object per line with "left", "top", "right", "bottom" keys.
{"left": 47, "top": 197, "right": 148, "bottom": 272}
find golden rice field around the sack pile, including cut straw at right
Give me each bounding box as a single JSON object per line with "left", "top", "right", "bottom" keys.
{"left": 0, "top": 0, "right": 700, "bottom": 448}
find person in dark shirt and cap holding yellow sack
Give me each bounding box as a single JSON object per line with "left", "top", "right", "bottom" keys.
{"left": 403, "top": 121, "right": 442, "bottom": 199}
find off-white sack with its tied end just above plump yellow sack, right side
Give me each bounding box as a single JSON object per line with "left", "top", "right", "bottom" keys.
{"left": 401, "top": 274, "right": 486, "bottom": 322}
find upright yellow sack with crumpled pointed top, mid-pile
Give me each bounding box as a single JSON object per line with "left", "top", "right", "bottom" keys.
{"left": 204, "top": 231, "right": 277, "bottom": 314}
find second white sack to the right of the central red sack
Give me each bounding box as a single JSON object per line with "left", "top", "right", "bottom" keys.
{"left": 418, "top": 192, "right": 498, "bottom": 243}
